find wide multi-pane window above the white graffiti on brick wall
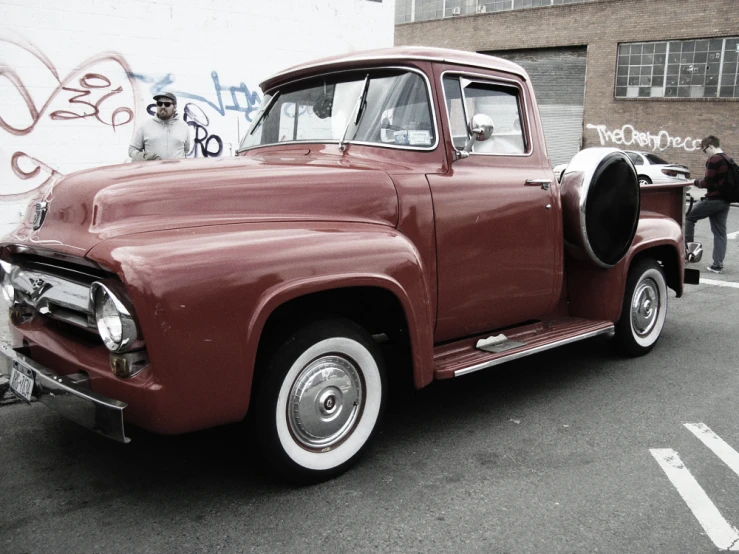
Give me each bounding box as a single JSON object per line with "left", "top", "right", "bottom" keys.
{"left": 616, "top": 37, "right": 739, "bottom": 98}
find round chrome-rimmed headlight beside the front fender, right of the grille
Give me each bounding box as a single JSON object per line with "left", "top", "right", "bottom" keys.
{"left": 90, "top": 281, "right": 138, "bottom": 352}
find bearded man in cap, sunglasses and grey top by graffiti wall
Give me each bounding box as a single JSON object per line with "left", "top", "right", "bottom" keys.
{"left": 128, "top": 92, "right": 192, "bottom": 161}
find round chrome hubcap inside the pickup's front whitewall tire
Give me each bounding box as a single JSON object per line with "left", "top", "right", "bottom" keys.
{"left": 287, "top": 355, "right": 364, "bottom": 450}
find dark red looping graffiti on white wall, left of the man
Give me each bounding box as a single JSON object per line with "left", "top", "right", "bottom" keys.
{"left": 0, "top": 35, "right": 136, "bottom": 201}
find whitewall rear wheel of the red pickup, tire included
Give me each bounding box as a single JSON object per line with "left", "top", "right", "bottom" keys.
{"left": 616, "top": 258, "right": 667, "bottom": 356}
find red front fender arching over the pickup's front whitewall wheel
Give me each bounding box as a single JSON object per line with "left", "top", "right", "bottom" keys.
{"left": 88, "top": 223, "right": 433, "bottom": 432}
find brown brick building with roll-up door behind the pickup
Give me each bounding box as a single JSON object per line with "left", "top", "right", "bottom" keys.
{"left": 395, "top": 0, "right": 739, "bottom": 176}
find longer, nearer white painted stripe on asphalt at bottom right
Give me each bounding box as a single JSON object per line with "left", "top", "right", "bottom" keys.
{"left": 649, "top": 448, "right": 739, "bottom": 552}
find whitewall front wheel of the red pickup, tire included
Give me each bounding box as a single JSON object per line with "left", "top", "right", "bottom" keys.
{"left": 256, "top": 318, "right": 386, "bottom": 484}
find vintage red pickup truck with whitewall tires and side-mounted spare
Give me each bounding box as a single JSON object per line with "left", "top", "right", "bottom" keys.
{"left": 0, "top": 48, "right": 692, "bottom": 482}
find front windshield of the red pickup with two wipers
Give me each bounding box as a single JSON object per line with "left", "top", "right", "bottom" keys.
{"left": 240, "top": 70, "right": 436, "bottom": 149}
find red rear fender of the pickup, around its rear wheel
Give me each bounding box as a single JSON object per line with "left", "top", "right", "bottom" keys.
{"left": 567, "top": 211, "right": 685, "bottom": 323}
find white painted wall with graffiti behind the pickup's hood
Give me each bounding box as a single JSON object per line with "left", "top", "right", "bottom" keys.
{"left": 0, "top": 0, "right": 395, "bottom": 234}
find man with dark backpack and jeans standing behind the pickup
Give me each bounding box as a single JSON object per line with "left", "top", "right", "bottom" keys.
{"left": 685, "top": 135, "right": 739, "bottom": 273}
